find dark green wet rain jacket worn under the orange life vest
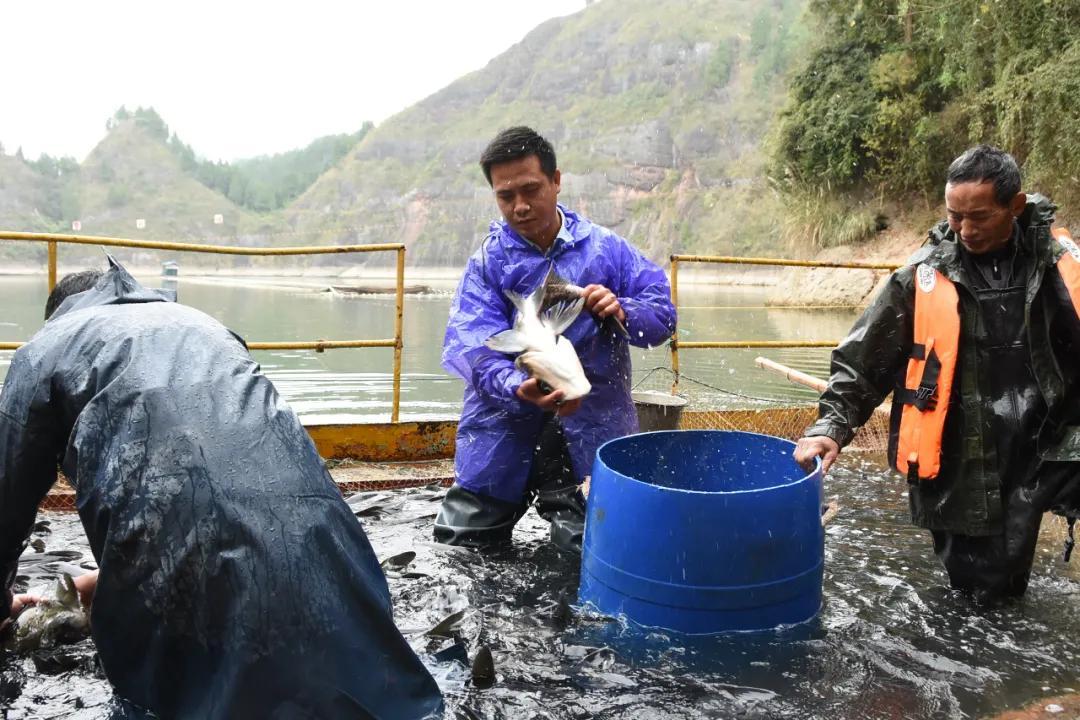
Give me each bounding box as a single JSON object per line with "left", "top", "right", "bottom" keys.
{"left": 807, "top": 195, "right": 1080, "bottom": 535}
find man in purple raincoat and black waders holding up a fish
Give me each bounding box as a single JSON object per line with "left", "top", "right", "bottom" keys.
{"left": 435, "top": 127, "right": 675, "bottom": 552}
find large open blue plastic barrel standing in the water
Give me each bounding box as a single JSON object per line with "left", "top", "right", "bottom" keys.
{"left": 579, "top": 430, "right": 824, "bottom": 634}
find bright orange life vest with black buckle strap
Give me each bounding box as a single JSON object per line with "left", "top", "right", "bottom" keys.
{"left": 893, "top": 228, "right": 1080, "bottom": 483}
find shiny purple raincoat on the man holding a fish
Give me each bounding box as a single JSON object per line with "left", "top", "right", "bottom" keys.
{"left": 443, "top": 205, "right": 675, "bottom": 502}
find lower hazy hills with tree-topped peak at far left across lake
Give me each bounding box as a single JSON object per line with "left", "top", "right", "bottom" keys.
{"left": 0, "top": 108, "right": 372, "bottom": 260}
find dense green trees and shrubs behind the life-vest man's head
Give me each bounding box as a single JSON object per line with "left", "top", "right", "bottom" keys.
{"left": 773, "top": 0, "right": 1080, "bottom": 245}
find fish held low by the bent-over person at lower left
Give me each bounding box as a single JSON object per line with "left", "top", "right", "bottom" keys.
{"left": 3, "top": 573, "right": 90, "bottom": 652}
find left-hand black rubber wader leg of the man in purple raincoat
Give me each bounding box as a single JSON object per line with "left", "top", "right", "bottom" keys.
{"left": 435, "top": 484, "right": 528, "bottom": 547}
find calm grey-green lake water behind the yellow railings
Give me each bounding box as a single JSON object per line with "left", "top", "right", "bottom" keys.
{"left": 0, "top": 275, "right": 858, "bottom": 424}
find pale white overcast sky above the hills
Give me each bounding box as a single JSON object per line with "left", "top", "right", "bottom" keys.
{"left": 0, "top": 0, "right": 585, "bottom": 161}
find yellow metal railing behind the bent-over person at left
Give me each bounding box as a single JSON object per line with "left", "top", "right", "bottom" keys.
{"left": 0, "top": 232, "right": 405, "bottom": 422}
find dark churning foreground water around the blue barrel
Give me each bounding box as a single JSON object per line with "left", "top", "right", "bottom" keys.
{"left": 6, "top": 456, "right": 1080, "bottom": 720}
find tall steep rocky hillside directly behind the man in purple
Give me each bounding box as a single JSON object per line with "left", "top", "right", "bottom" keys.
{"left": 286, "top": 0, "right": 802, "bottom": 266}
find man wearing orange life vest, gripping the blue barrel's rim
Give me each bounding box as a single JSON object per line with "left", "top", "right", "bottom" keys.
{"left": 795, "top": 145, "right": 1080, "bottom": 600}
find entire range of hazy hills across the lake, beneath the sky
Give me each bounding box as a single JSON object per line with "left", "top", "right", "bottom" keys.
{"left": 0, "top": 0, "right": 807, "bottom": 267}
